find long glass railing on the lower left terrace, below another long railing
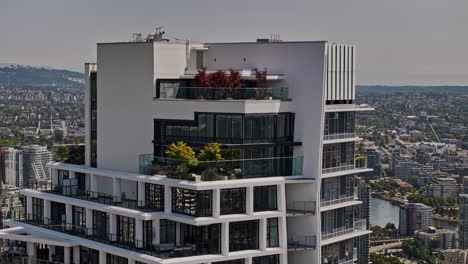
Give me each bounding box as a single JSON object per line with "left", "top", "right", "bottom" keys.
{"left": 13, "top": 214, "right": 209, "bottom": 258}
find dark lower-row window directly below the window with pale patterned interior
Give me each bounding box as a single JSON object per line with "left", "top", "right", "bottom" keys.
{"left": 180, "top": 224, "right": 221, "bottom": 255}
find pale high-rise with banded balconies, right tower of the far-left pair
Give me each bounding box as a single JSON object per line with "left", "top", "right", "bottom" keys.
{"left": 23, "top": 145, "right": 52, "bottom": 186}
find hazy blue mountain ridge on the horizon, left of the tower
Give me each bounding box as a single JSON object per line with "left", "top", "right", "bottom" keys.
{"left": 0, "top": 65, "right": 84, "bottom": 88}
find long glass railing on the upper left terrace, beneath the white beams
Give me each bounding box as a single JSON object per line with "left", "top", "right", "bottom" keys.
{"left": 26, "top": 184, "right": 164, "bottom": 212}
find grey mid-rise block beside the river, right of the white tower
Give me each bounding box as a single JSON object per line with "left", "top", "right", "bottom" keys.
{"left": 399, "top": 203, "right": 432, "bottom": 236}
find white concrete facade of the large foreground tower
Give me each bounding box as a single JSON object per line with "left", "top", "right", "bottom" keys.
{"left": 0, "top": 37, "right": 372, "bottom": 264}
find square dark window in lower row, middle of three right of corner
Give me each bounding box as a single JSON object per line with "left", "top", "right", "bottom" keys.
{"left": 229, "top": 220, "right": 258, "bottom": 251}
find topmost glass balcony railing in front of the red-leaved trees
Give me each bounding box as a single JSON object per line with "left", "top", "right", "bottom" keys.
{"left": 159, "top": 87, "right": 289, "bottom": 100}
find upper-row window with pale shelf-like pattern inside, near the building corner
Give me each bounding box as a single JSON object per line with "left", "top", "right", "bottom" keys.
{"left": 172, "top": 187, "right": 213, "bottom": 216}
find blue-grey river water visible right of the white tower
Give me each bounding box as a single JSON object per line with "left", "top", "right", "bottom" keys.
{"left": 370, "top": 198, "right": 458, "bottom": 231}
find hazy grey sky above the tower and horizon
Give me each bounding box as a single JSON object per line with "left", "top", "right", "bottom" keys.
{"left": 0, "top": 0, "right": 468, "bottom": 85}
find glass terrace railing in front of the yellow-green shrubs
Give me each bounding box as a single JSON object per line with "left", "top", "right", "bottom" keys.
{"left": 139, "top": 154, "right": 303, "bottom": 181}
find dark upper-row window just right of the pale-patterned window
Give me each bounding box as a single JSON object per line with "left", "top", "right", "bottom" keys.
{"left": 221, "top": 188, "right": 245, "bottom": 215}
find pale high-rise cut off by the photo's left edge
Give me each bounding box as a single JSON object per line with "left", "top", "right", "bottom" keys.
{"left": 0, "top": 148, "right": 23, "bottom": 188}
